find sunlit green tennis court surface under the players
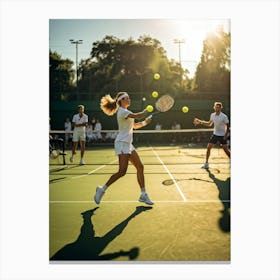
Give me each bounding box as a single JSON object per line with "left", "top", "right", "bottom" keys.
{"left": 49, "top": 146, "right": 230, "bottom": 262}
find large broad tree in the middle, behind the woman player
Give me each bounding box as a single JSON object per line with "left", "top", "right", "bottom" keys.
{"left": 79, "top": 36, "right": 187, "bottom": 98}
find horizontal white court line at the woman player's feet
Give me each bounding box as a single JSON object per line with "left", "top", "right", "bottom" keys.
{"left": 49, "top": 199, "right": 230, "bottom": 204}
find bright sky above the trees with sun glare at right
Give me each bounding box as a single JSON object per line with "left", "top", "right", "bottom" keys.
{"left": 49, "top": 19, "right": 230, "bottom": 77}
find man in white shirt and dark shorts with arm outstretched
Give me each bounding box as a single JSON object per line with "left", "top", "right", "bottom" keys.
{"left": 193, "top": 102, "right": 230, "bottom": 169}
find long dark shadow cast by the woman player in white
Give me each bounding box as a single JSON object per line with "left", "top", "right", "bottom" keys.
{"left": 50, "top": 206, "right": 153, "bottom": 261}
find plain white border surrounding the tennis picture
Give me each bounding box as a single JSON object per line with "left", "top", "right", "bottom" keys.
{"left": 0, "top": 0, "right": 280, "bottom": 280}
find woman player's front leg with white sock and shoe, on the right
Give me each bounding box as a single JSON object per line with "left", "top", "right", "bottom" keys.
{"left": 129, "top": 150, "right": 154, "bottom": 205}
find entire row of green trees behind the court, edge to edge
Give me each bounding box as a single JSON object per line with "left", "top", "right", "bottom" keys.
{"left": 50, "top": 29, "right": 230, "bottom": 101}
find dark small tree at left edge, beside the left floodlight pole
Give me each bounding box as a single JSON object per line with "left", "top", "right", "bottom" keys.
{"left": 49, "top": 51, "right": 74, "bottom": 100}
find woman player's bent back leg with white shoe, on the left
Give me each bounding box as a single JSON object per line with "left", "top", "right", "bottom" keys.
{"left": 94, "top": 154, "right": 130, "bottom": 204}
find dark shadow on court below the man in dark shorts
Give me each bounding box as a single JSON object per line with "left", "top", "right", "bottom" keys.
{"left": 207, "top": 169, "right": 230, "bottom": 232}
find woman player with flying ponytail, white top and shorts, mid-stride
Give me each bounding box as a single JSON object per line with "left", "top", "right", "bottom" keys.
{"left": 94, "top": 92, "right": 154, "bottom": 205}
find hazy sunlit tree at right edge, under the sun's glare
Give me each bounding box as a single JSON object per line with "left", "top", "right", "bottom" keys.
{"left": 194, "top": 29, "right": 230, "bottom": 92}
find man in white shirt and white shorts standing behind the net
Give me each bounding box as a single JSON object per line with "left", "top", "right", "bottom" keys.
{"left": 70, "top": 105, "right": 88, "bottom": 165}
